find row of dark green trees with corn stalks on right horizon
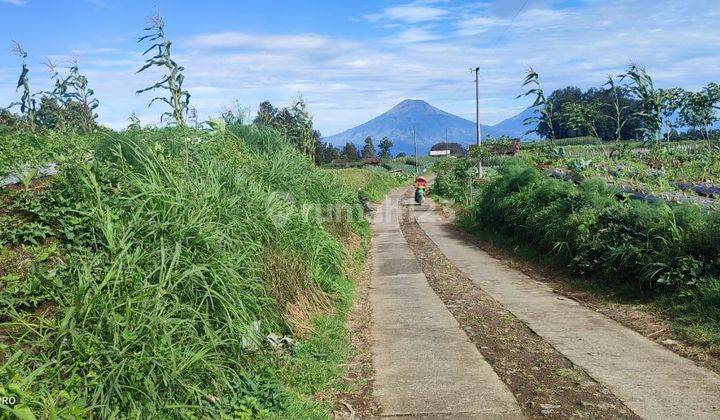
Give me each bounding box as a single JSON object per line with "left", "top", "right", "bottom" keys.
{"left": 518, "top": 64, "right": 720, "bottom": 142}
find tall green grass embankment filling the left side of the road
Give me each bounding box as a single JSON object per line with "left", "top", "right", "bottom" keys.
{"left": 0, "top": 128, "right": 404, "bottom": 418}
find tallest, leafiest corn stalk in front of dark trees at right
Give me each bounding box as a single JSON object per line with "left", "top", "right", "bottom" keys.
{"left": 619, "top": 64, "right": 664, "bottom": 142}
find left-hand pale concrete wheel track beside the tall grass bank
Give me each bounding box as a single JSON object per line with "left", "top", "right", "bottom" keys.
{"left": 370, "top": 191, "right": 522, "bottom": 418}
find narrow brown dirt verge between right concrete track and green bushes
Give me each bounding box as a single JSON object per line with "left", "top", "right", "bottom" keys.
{"left": 441, "top": 207, "right": 720, "bottom": 374}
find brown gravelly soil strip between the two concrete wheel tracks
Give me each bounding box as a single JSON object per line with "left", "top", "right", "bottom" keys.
{"left": 401, "top": 195, "right": 638, "bottom": 419}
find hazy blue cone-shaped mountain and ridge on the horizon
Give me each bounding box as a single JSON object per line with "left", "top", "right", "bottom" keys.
{"left": 325, "top": 99, "right": 533, "bottom": 155}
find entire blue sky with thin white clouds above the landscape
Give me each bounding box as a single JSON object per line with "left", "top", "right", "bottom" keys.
{"left": 0, "top": 0, "right": 720, "bottom": 135}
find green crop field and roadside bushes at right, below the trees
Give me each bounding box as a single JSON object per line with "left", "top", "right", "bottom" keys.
{"left": 432, "top": 143, "right": 720, "bottom": 352}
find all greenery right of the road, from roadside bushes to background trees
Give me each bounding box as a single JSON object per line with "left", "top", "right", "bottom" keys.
{"left": 432, "top": 66, "right": 720, "bottom": 355}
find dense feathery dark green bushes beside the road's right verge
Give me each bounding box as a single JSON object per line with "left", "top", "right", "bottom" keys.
{"left": 474, "top": 164, "right": 720, "bottom": 290}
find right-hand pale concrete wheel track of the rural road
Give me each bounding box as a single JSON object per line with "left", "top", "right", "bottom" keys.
{"left": 414, "top": 197, "right": 720, "bottom": 418}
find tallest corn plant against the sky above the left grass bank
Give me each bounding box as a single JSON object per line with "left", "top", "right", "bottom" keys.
{"left": 136, "top": 13, "right": 190, "bottom": 126}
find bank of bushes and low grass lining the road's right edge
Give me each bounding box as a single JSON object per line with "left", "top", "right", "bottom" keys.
{"left": 435, "top": 161, "right": 720, "bottom": 352}
